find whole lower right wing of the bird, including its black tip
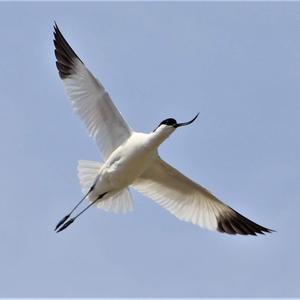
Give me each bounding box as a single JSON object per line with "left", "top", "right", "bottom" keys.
{"left": 133, "top": 157, "right": 272, "bottom": 235}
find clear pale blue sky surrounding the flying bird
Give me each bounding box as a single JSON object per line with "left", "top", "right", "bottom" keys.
{"left": 0, "top": 2, "right": 300, "bottom": 297}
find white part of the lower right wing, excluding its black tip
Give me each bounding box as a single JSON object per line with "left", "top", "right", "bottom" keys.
{"left": 133, "top": 158, "right": 223, "bottom": 230}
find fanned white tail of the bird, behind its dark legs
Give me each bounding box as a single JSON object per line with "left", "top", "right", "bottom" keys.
{"left": 77, "top": 160, "right": 133, "bottom": 213}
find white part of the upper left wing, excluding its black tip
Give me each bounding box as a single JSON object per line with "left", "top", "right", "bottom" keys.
{"left": 63, "top": 59, "right": 131, "bottom": 159}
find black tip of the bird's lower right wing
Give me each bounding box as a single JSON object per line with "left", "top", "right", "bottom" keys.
{"left": 217, "top": 210, "right": 275, "bottom": 235}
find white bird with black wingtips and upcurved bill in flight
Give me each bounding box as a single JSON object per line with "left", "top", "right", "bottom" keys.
{"left": 54, "top": 23, "right": 273, "bottom": 235}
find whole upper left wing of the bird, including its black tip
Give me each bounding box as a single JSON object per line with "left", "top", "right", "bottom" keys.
{"left": 54, "top": 24, "right": 132, "bottom": 158}
